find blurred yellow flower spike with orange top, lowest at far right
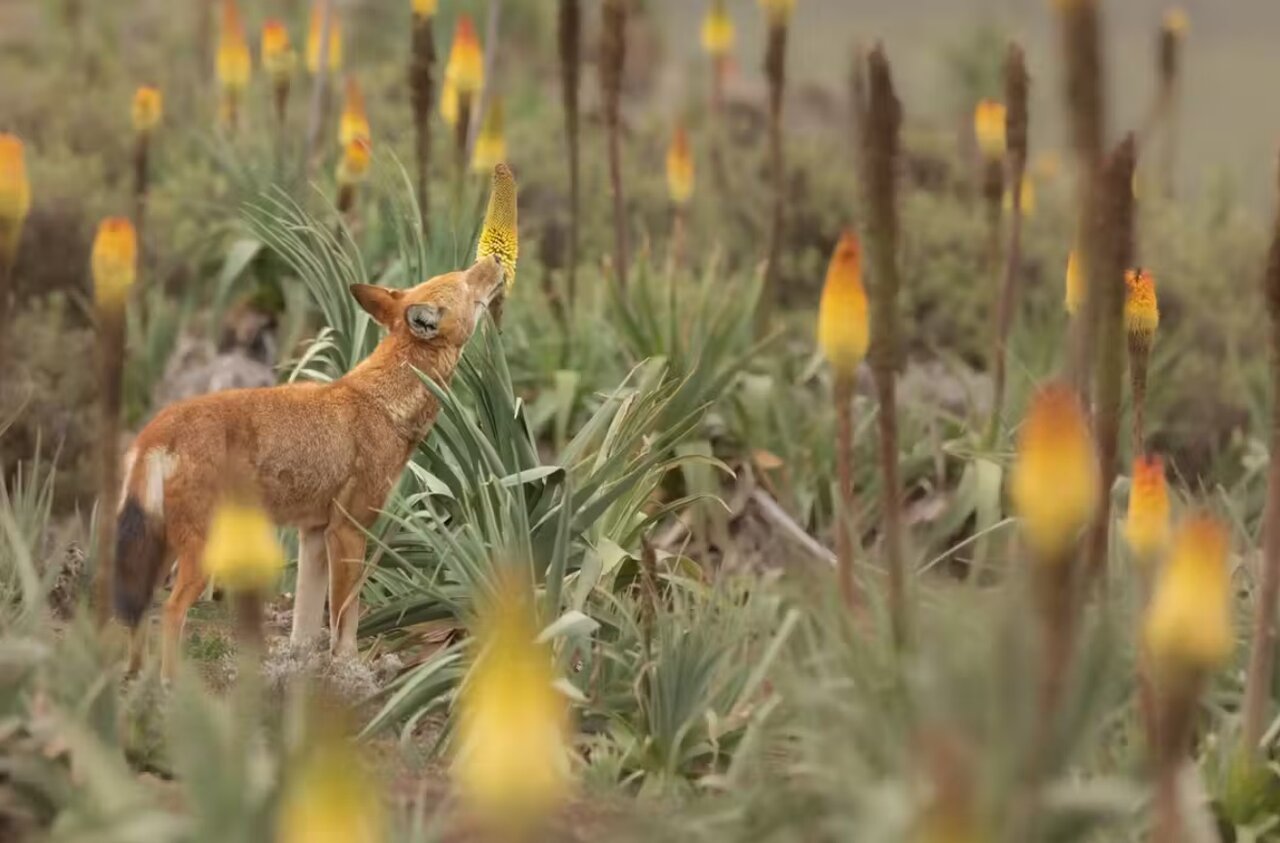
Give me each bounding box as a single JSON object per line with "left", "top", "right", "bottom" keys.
{"left": 1143, "top": 516, "right": 1235, "bottom": 682}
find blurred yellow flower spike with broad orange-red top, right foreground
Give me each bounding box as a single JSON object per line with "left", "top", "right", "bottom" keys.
{"left": 1010, "top": 384, "right": 1100, "bottom": 563}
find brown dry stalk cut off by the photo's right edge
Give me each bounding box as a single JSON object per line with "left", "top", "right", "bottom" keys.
{"left": 1243, "top": 150, "right": 1280, "bottom": 752}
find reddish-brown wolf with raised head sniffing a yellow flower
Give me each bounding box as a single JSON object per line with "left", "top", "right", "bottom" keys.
{"left": 116, "top": 258, "right": 502, "bottom": 674}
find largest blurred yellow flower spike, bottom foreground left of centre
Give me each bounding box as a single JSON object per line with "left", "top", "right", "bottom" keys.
{"left": 453, "top": 573, "right": 571, "bottom": 839}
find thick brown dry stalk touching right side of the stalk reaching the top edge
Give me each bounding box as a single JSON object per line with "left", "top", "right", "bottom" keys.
{"left": 1085, "top": 134, "right": 1137, "bottom": 581}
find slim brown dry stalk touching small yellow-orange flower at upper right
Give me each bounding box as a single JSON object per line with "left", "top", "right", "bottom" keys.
{"left": 987, "top": 43, "right": 1030, "bottom": 444}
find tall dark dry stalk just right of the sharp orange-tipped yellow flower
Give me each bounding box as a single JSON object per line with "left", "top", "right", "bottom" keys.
{"left": 861, "top": 45, "right": 908, "bottom": 643}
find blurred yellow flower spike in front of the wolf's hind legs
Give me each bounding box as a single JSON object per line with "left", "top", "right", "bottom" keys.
{"left": 204, "top": 500, "right": 284, "bottom": 594}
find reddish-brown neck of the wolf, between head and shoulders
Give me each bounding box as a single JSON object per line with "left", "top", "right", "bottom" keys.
{"left": 338, "top": 336, "right": 458, "bottom": 444}
